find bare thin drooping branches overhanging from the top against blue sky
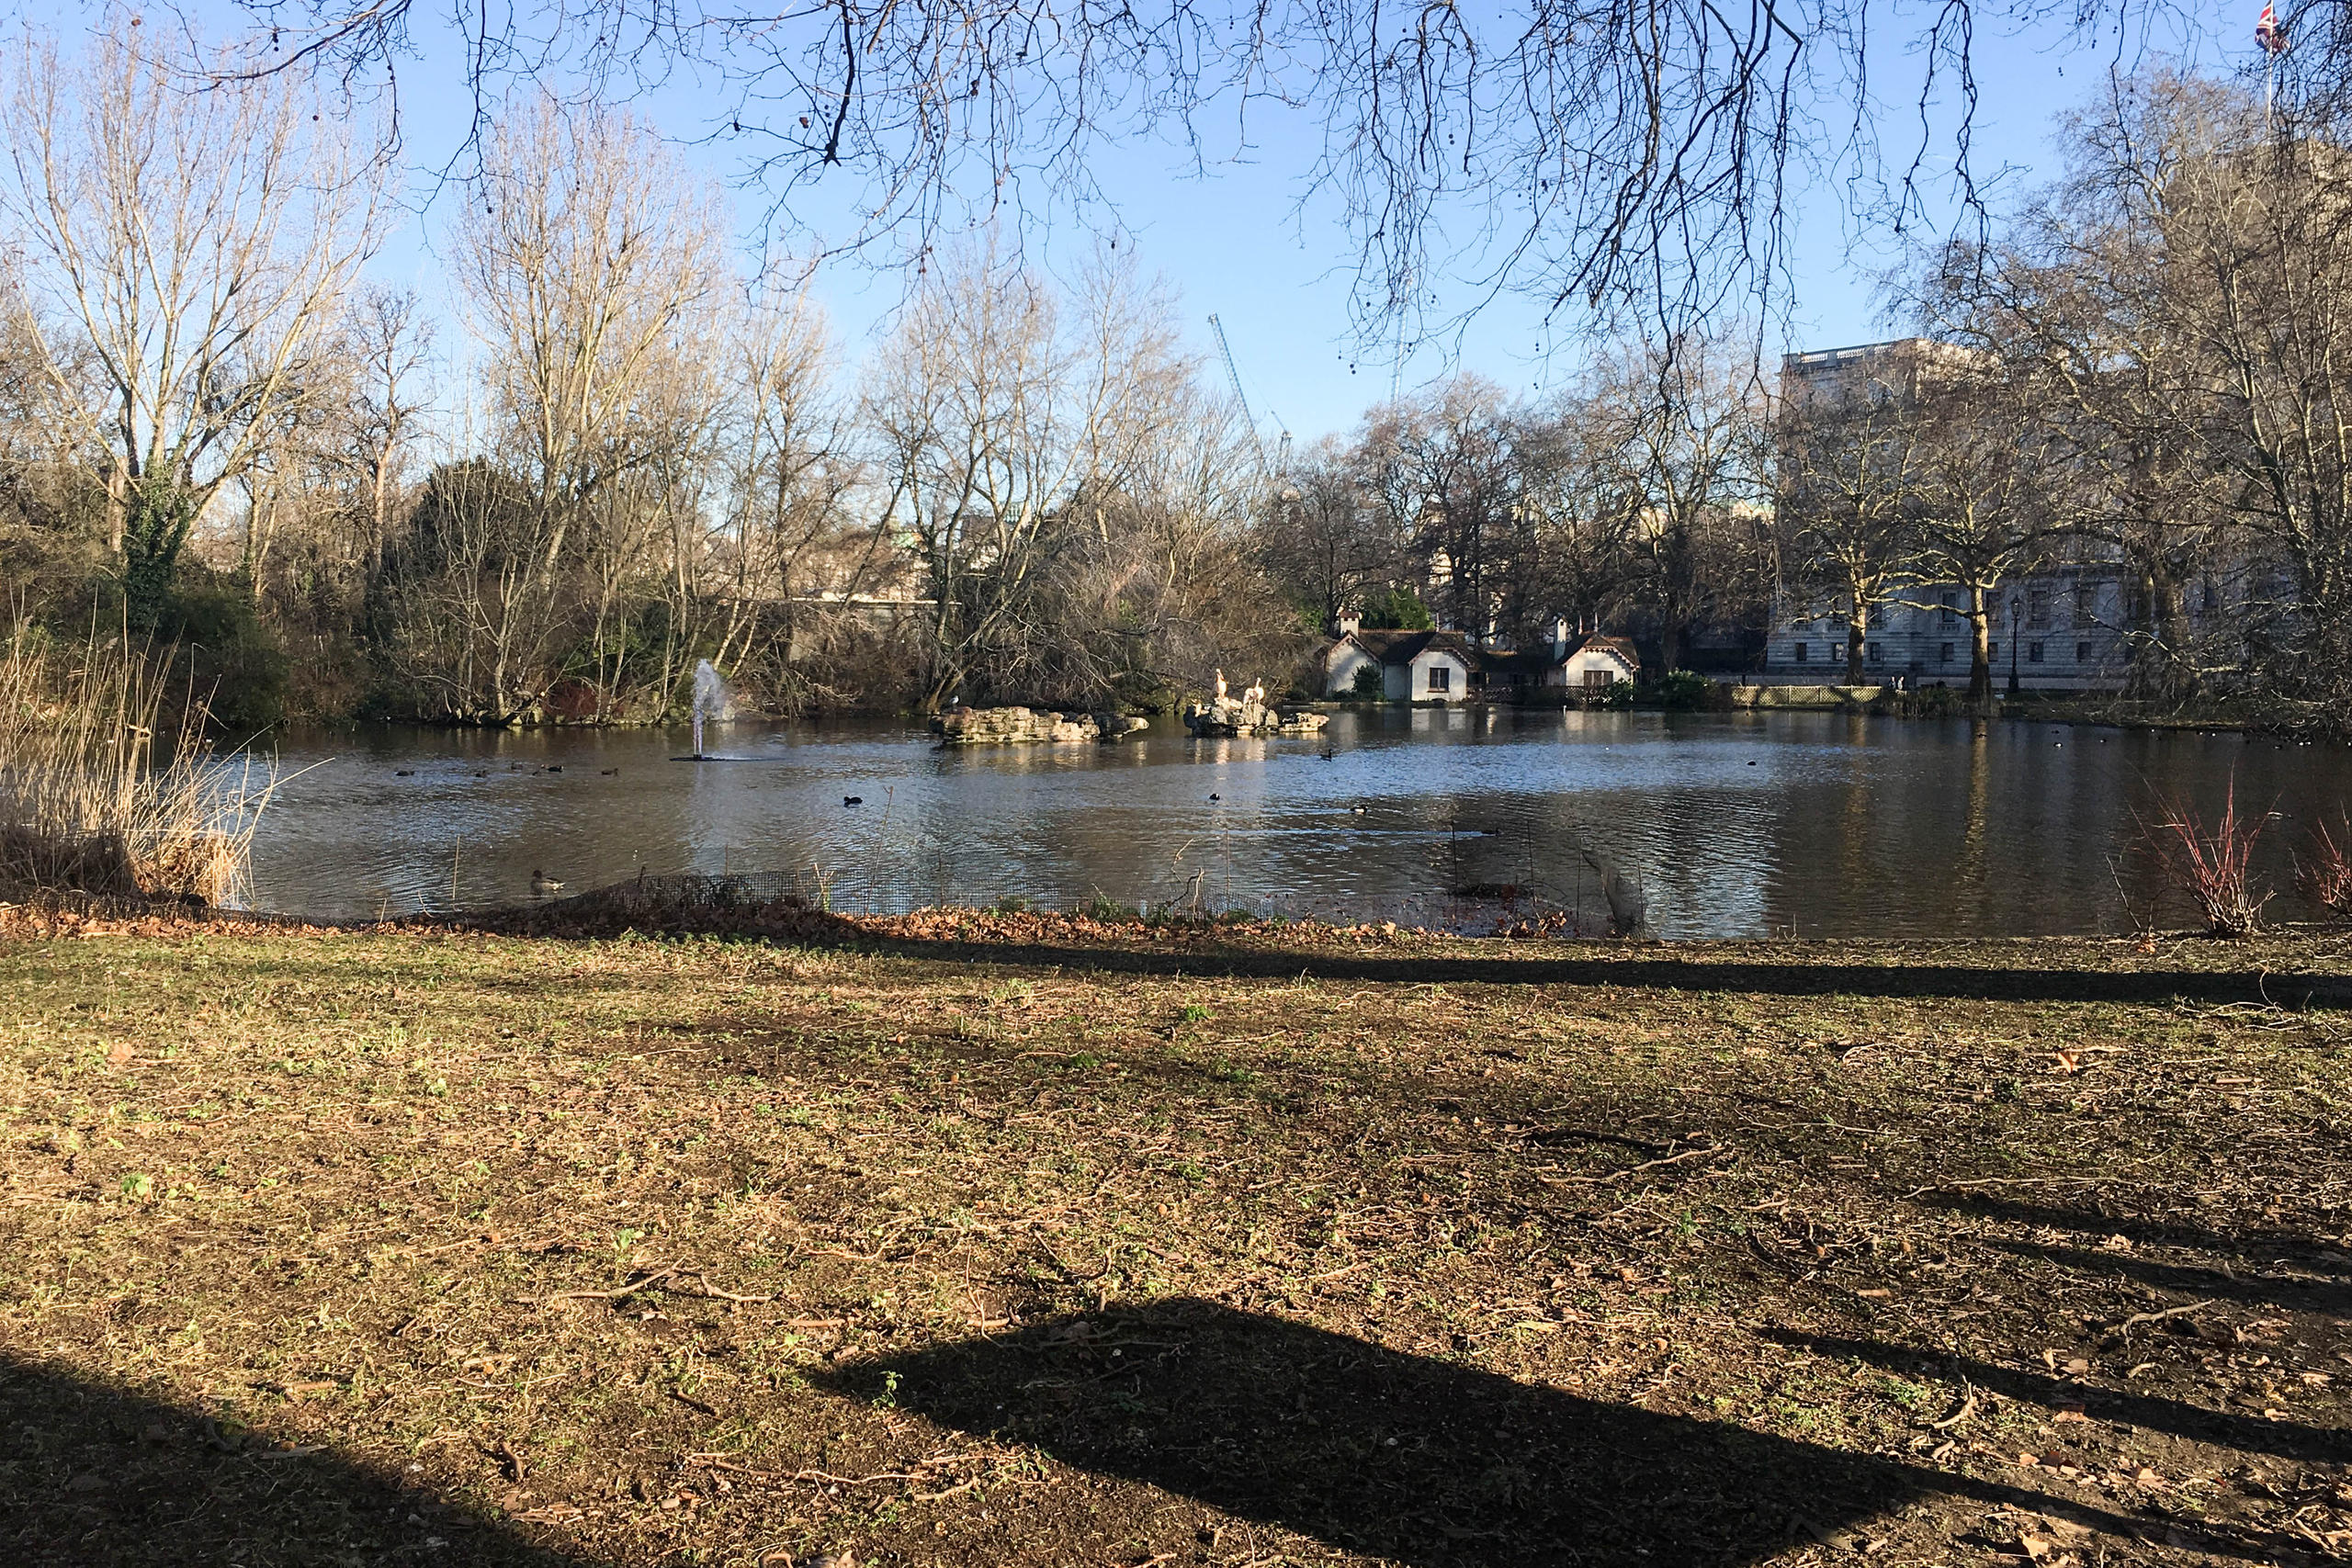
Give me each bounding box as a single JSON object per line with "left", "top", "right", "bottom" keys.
{"left": 224, "top": 0, "right": 2121, "bottom": 344}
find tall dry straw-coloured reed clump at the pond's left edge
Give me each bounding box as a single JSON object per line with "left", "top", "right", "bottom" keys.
{"left": 0, "top": 621, "right": 268, "bottom": 903}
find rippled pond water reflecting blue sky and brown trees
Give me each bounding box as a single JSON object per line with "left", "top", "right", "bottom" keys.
{"left": 254, "top": 710, "right": 2352, "bottom": 936}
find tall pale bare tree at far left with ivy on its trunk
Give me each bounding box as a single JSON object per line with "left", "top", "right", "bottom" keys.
{"left": 5, "top": 14, "right": 388, "bottom": 616}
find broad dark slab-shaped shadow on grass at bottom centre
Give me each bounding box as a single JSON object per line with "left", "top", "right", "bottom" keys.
{"left": 828, "top": 1300, "right": 2277, "bottom": 1568}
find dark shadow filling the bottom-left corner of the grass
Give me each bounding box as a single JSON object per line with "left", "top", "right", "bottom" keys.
{"left": 0, "top": 1354, "right": 571, "bottom": 1568}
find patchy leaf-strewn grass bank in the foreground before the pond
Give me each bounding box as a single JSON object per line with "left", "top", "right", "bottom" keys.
{"left": 0, "top": 912, "right": 2352, "bottom": 1568}
